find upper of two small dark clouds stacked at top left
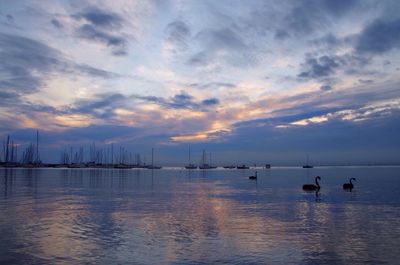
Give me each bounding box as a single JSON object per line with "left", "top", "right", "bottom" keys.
{"left": 72, "top": 7, "right": 124, "bottom": 29}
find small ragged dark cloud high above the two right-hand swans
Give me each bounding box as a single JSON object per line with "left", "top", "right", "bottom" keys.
{"left": 298, "top": 55, "right": 340, "bottom": 78}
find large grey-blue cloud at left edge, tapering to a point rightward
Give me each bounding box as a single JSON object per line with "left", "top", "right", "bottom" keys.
{"left": 0, "top": 33, "right": 118, "bottom": 100}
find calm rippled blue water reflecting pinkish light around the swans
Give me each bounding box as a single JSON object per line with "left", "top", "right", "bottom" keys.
{"left": 0, "top": 167, "right": 400, "bottom": 264}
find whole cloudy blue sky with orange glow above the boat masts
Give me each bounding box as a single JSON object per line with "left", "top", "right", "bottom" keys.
{"left": 0, "top": 0, "right": 400, "bottom": 165}
